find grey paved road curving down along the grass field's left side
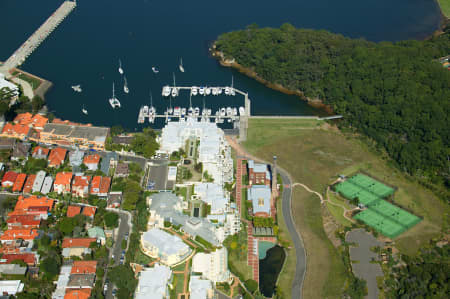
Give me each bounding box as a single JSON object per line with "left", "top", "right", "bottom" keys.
{"left": 277, "top": 168, "right": 306, "bottom": 299}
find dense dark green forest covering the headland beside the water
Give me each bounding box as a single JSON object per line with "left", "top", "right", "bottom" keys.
{"left": 216, "top": 24, "right": 450, "bottom": 190}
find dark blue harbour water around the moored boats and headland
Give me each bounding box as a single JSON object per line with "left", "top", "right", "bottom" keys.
{"left": 0, "top": 0, "right": 440, "bottom": 129}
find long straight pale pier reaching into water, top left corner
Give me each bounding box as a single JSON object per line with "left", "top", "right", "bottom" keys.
{"left": 0, "top": 1, "right": 77, "bottom": 73}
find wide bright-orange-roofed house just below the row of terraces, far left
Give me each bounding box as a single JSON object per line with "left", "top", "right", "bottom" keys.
{"left": 8, "top": 195, "right": 55, "bottom": 219}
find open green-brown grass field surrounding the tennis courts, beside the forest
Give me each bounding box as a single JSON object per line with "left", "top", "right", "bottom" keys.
{"left": 243, "top": 119, "right": 449, "bottom": 298}
